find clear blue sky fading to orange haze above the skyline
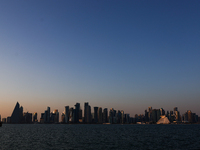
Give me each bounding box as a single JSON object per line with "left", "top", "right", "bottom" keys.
{"left": 0, "top": 0, "right": 200, "bottom": 119}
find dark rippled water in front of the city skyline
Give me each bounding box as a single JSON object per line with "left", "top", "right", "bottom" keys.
{"left": 0, "top": 124, "right": 200, "bottom": 150}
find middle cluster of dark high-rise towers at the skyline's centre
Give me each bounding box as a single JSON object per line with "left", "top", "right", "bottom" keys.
{"left": 58, "top": 102, "right": 131, "bottom": 124}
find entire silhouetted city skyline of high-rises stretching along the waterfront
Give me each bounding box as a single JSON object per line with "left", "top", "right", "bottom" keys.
{"left": 0, "top": 102, "right": 200, "bottom": 124}
